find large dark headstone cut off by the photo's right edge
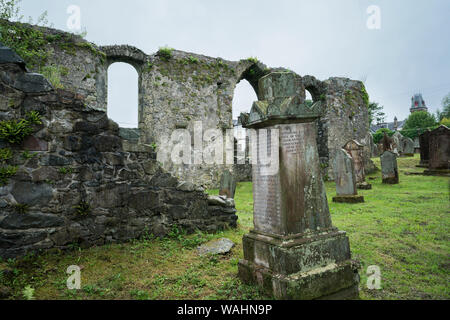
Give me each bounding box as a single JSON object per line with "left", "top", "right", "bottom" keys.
{"left": 424, "top": 125, "right": 450, "bottom": 176}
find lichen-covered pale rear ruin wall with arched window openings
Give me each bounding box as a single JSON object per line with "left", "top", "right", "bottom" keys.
{"left": 0, "top": 20, "right": 372, "bottom": 188}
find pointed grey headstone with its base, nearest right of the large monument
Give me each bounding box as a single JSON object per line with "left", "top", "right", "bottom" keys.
{"left": 333, "top": 149, "right": 364, "bottom": 203}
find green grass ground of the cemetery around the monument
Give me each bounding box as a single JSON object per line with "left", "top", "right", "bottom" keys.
{"left": 0, "top": 155, "right": 450, "bottom": 300}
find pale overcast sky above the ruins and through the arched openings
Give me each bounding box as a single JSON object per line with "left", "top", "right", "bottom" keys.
{"left": 21, "top": 0, "right": 450, "bottom": 124}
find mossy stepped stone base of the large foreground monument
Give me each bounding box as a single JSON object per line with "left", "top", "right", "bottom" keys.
{"left": 238, "top": 229, "right": 359, "bottom": 300}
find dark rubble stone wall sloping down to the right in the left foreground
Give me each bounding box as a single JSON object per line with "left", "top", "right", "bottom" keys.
{"left": 0, "top": 45, "right": 237, "bottom": 258}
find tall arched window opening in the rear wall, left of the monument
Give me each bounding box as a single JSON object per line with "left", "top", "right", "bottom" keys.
{"left": 107, "top": 62, "right": 139, "bottom": 128}
